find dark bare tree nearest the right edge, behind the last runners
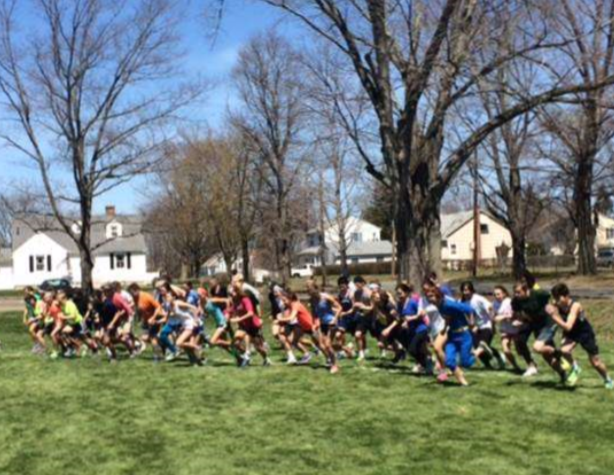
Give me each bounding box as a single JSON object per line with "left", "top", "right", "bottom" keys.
{"left": 542, "top": 0, "right": 614, "bottom": 275}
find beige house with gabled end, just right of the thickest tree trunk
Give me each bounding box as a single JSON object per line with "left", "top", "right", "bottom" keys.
{"left": 441, "top": 211, "right": 512, "bottom": 267}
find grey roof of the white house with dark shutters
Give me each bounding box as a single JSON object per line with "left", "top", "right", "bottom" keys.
{"left": 13, "top": 215, "right": 147, "bottom": 255}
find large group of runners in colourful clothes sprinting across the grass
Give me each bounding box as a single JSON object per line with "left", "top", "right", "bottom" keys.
{"left": 24, "top": 273, "right": 614, "bottom": 389}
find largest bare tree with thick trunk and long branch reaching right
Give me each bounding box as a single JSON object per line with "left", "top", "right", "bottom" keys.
{"left": 262, "top": 0, "right": 613, "bottom": 281}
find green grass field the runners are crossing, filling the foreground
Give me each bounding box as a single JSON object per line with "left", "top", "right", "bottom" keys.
{"left": 0, "top": 302, "right": 614, "bottom": 475}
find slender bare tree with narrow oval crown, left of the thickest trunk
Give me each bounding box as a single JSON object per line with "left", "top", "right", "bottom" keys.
{"left": 232, "top": 31, "right": 316, "bottom": 282}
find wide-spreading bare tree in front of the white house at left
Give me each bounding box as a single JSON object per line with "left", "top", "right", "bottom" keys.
{"left": 0, "top": 0, "right": 201, "bottom": 292}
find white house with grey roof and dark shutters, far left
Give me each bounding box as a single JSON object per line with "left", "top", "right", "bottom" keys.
{"left": 0, "top": 206, "right": 157, "bottom": 288}
